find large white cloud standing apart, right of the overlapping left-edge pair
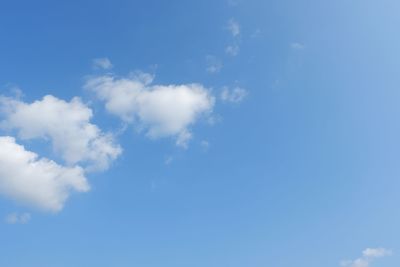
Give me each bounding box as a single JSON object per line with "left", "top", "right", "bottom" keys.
{"left": 85, "top": 73, "right": 214, "bottom": 147}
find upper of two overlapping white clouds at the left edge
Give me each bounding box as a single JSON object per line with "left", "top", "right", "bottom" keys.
{"left": 0, "top": 95, "right": 121, "bottom": 173}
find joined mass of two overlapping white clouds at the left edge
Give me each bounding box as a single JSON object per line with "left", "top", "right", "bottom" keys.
{"left": 0, "top": 95, "right": 122, "bottom": 212}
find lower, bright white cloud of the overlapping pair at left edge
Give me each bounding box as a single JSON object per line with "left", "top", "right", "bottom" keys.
{"left": 0, "top": 136, "right": 89, "bottom": 212}
